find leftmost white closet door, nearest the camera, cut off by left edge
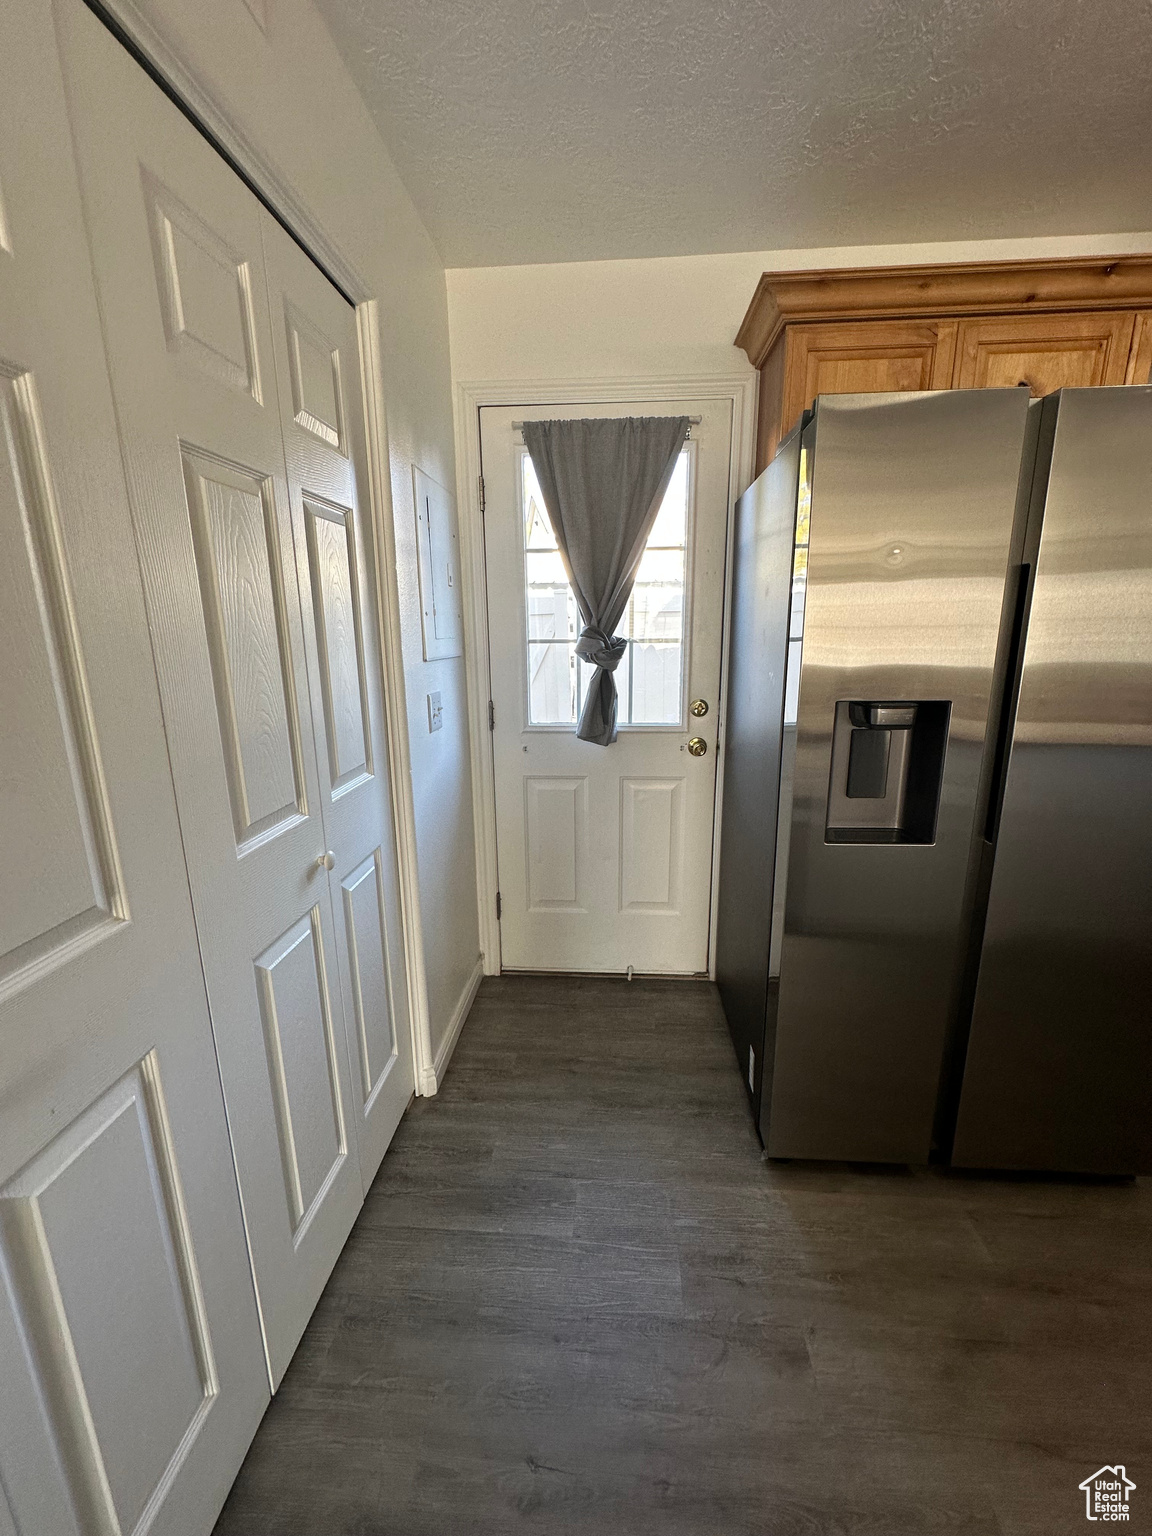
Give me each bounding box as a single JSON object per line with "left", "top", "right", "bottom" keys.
{"left": 0, "top": 3, "right": 269, "bottom": 1536}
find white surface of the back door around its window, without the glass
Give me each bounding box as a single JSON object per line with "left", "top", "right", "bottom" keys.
{"left": 481, "top": 398, "right": 733, "bottom": 974}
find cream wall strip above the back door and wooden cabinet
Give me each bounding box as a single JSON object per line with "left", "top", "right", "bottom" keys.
{"left": 447, "top": 233, "right": 1152, "bottom": 396}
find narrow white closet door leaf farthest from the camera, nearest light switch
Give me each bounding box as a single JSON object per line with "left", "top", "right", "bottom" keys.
{"left": 261, "top": 212, "right": 413, "bottom": 1190}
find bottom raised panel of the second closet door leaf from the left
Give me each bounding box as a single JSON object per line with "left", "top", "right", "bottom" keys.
{"left": 255, "top": 906, "right": 349, "bottom": 1244}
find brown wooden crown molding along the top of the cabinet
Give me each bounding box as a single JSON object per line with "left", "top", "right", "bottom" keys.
{"left": 736, "top": 253, "right": 1152, "bottom": 369}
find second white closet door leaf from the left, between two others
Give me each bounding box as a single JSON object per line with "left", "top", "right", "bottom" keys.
{"left": 58, "top": 0, "right": 362, "bottom": 1387}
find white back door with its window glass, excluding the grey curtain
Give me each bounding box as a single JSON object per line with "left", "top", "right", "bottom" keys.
{"left": 481, "top": 401, "right": 731, "bottom": 975}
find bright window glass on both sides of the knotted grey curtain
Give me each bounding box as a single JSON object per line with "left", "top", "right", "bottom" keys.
{"left": 521, "top": 449, "right": 688, "bottom": 727}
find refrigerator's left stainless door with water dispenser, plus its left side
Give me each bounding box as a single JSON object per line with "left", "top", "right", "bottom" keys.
{"left": 717, "top": 390, "right": 1032, "bottom": 1161}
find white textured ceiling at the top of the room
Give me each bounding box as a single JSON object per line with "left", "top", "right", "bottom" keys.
{"left": 318, "top": 0, "right": 1152, "bottom": 266}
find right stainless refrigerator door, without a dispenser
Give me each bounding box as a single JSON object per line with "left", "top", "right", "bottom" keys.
{"left": 951, "top": 387, "right": 1152, "bottom": 1174}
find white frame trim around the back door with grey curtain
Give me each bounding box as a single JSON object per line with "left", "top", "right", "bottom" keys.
{"left": 453, "top": 369, "right": 759, "bottom": 977}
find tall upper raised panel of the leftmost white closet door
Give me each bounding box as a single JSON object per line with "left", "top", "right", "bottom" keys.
{"left": 0, "top": 361, "right": 127, "bottom": 997}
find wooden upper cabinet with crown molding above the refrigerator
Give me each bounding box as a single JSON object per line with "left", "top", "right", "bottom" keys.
{"left": 736, "top": 257, "right": 1152, "bottom": 475}
